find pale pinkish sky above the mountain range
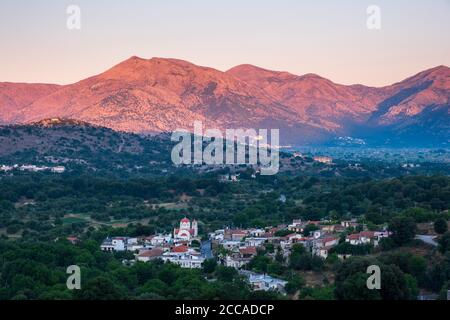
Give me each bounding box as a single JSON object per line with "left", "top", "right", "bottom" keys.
{"left": 0, "top": 0, "right": 450, "bottom": 86}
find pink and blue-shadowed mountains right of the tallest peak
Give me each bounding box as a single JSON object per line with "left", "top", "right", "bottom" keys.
{"left": 227, "top": 64, "right": 450, "bottom": 146}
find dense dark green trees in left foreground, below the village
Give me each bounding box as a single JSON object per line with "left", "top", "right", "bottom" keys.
{"left": 0, "top": 241, "right": 280, "bottom": 300}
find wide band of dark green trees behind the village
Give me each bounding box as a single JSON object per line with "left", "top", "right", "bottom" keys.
{"left": 0, "top": 173, "right": 450, "bottom": 240}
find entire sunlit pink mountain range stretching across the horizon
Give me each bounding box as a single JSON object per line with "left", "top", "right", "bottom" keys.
{"left": 0, "top": 57, "right": 450, "bottom": 145}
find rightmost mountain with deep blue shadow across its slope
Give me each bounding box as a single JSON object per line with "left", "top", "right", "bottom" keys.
{"left": 359, "top": 66, "right": 450, "bottom": 146}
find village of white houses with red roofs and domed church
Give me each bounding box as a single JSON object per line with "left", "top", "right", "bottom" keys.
{"left": 100, "top": 217, "right": 390, "bottom": 293}
